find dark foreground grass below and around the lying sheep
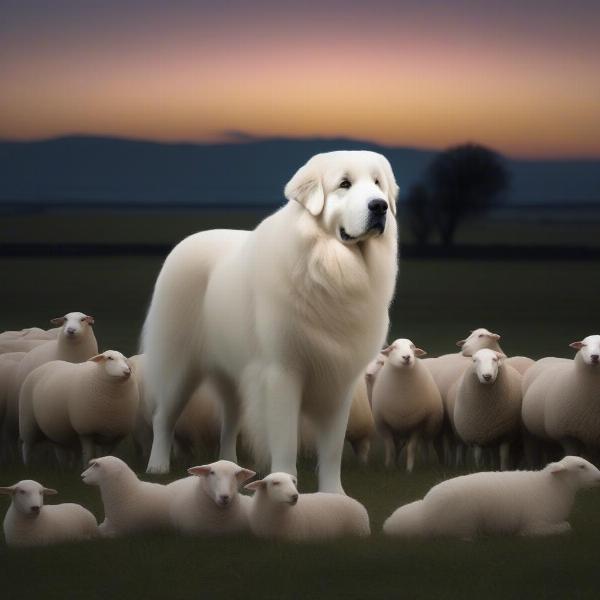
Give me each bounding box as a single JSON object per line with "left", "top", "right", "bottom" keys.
{"left": 0, "top": 458, "right": 600, "bottom": 599}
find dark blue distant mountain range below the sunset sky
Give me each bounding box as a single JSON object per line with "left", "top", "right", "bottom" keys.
{"left": 0, "top": 136, "right": 600, "bottom": 208}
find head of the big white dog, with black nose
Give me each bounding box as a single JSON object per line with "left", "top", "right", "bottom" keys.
{"left": 285, "top": 150, "right": 398, "bottom": 244}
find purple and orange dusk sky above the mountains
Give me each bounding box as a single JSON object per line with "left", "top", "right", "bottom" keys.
{"left": 0, "top": 0, "right": 600, "bottom": 157}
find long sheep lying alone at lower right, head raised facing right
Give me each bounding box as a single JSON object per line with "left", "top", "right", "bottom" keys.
{"left": 383, "top": 456, "right": 600, "bottom": 540}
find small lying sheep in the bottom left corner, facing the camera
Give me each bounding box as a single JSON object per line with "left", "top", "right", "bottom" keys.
{"left": 0, "top": 479, "right": 98, "bottom": 547}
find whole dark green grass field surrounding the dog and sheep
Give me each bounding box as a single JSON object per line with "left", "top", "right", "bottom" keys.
{"left": 0, "top": 214, "right": 600, "bottom": 599}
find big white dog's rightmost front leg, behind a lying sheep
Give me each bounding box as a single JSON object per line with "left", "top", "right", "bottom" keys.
{"left": 315, "top": 392, "right": 352, "bottom": 494}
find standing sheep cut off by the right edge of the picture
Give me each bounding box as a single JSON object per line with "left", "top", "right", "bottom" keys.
{"left": 522, "top": 335, "right": 600, "bottom": 454}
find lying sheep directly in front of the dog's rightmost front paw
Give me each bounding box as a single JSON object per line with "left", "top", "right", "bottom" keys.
{"left": 245, "top": 473, "right": 371, "bottom": 542}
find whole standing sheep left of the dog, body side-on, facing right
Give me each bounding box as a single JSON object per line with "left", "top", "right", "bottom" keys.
{"left": 19, "top": 350, "right": 138, "bottom": 466}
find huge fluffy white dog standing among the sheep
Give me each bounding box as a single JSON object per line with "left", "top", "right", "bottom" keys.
{"left": 142, "top": 151, "right": 398, "bottom": 492}
